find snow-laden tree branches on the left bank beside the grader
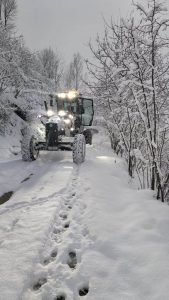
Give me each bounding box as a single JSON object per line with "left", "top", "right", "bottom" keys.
{"left": 0, "top": 22, "right": 59, "bottom": 133}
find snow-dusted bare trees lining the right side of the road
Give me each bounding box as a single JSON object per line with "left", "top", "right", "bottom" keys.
{"left": 87, "top": 0, "right": 169, "bottom": 201}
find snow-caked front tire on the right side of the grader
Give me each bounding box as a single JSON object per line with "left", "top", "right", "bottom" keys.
{"left": 73, "top": 134, "right": 86, "bottom": 164}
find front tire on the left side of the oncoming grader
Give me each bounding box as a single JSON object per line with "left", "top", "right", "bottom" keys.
{"left": 21, "top": 130, "right": 39, "bottom": 161}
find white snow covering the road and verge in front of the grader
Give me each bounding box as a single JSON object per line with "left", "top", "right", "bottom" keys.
{"left": 0, "top": 134, "right": 169, "bottom": 300}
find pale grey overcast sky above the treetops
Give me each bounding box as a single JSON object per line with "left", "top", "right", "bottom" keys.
{"left": 17, "top": 0, "right": 168, "bottom": 62}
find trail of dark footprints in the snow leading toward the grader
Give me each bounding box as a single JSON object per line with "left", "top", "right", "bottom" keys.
{"left": 29, "top": 171, "right": 89, "bottom": 300}
